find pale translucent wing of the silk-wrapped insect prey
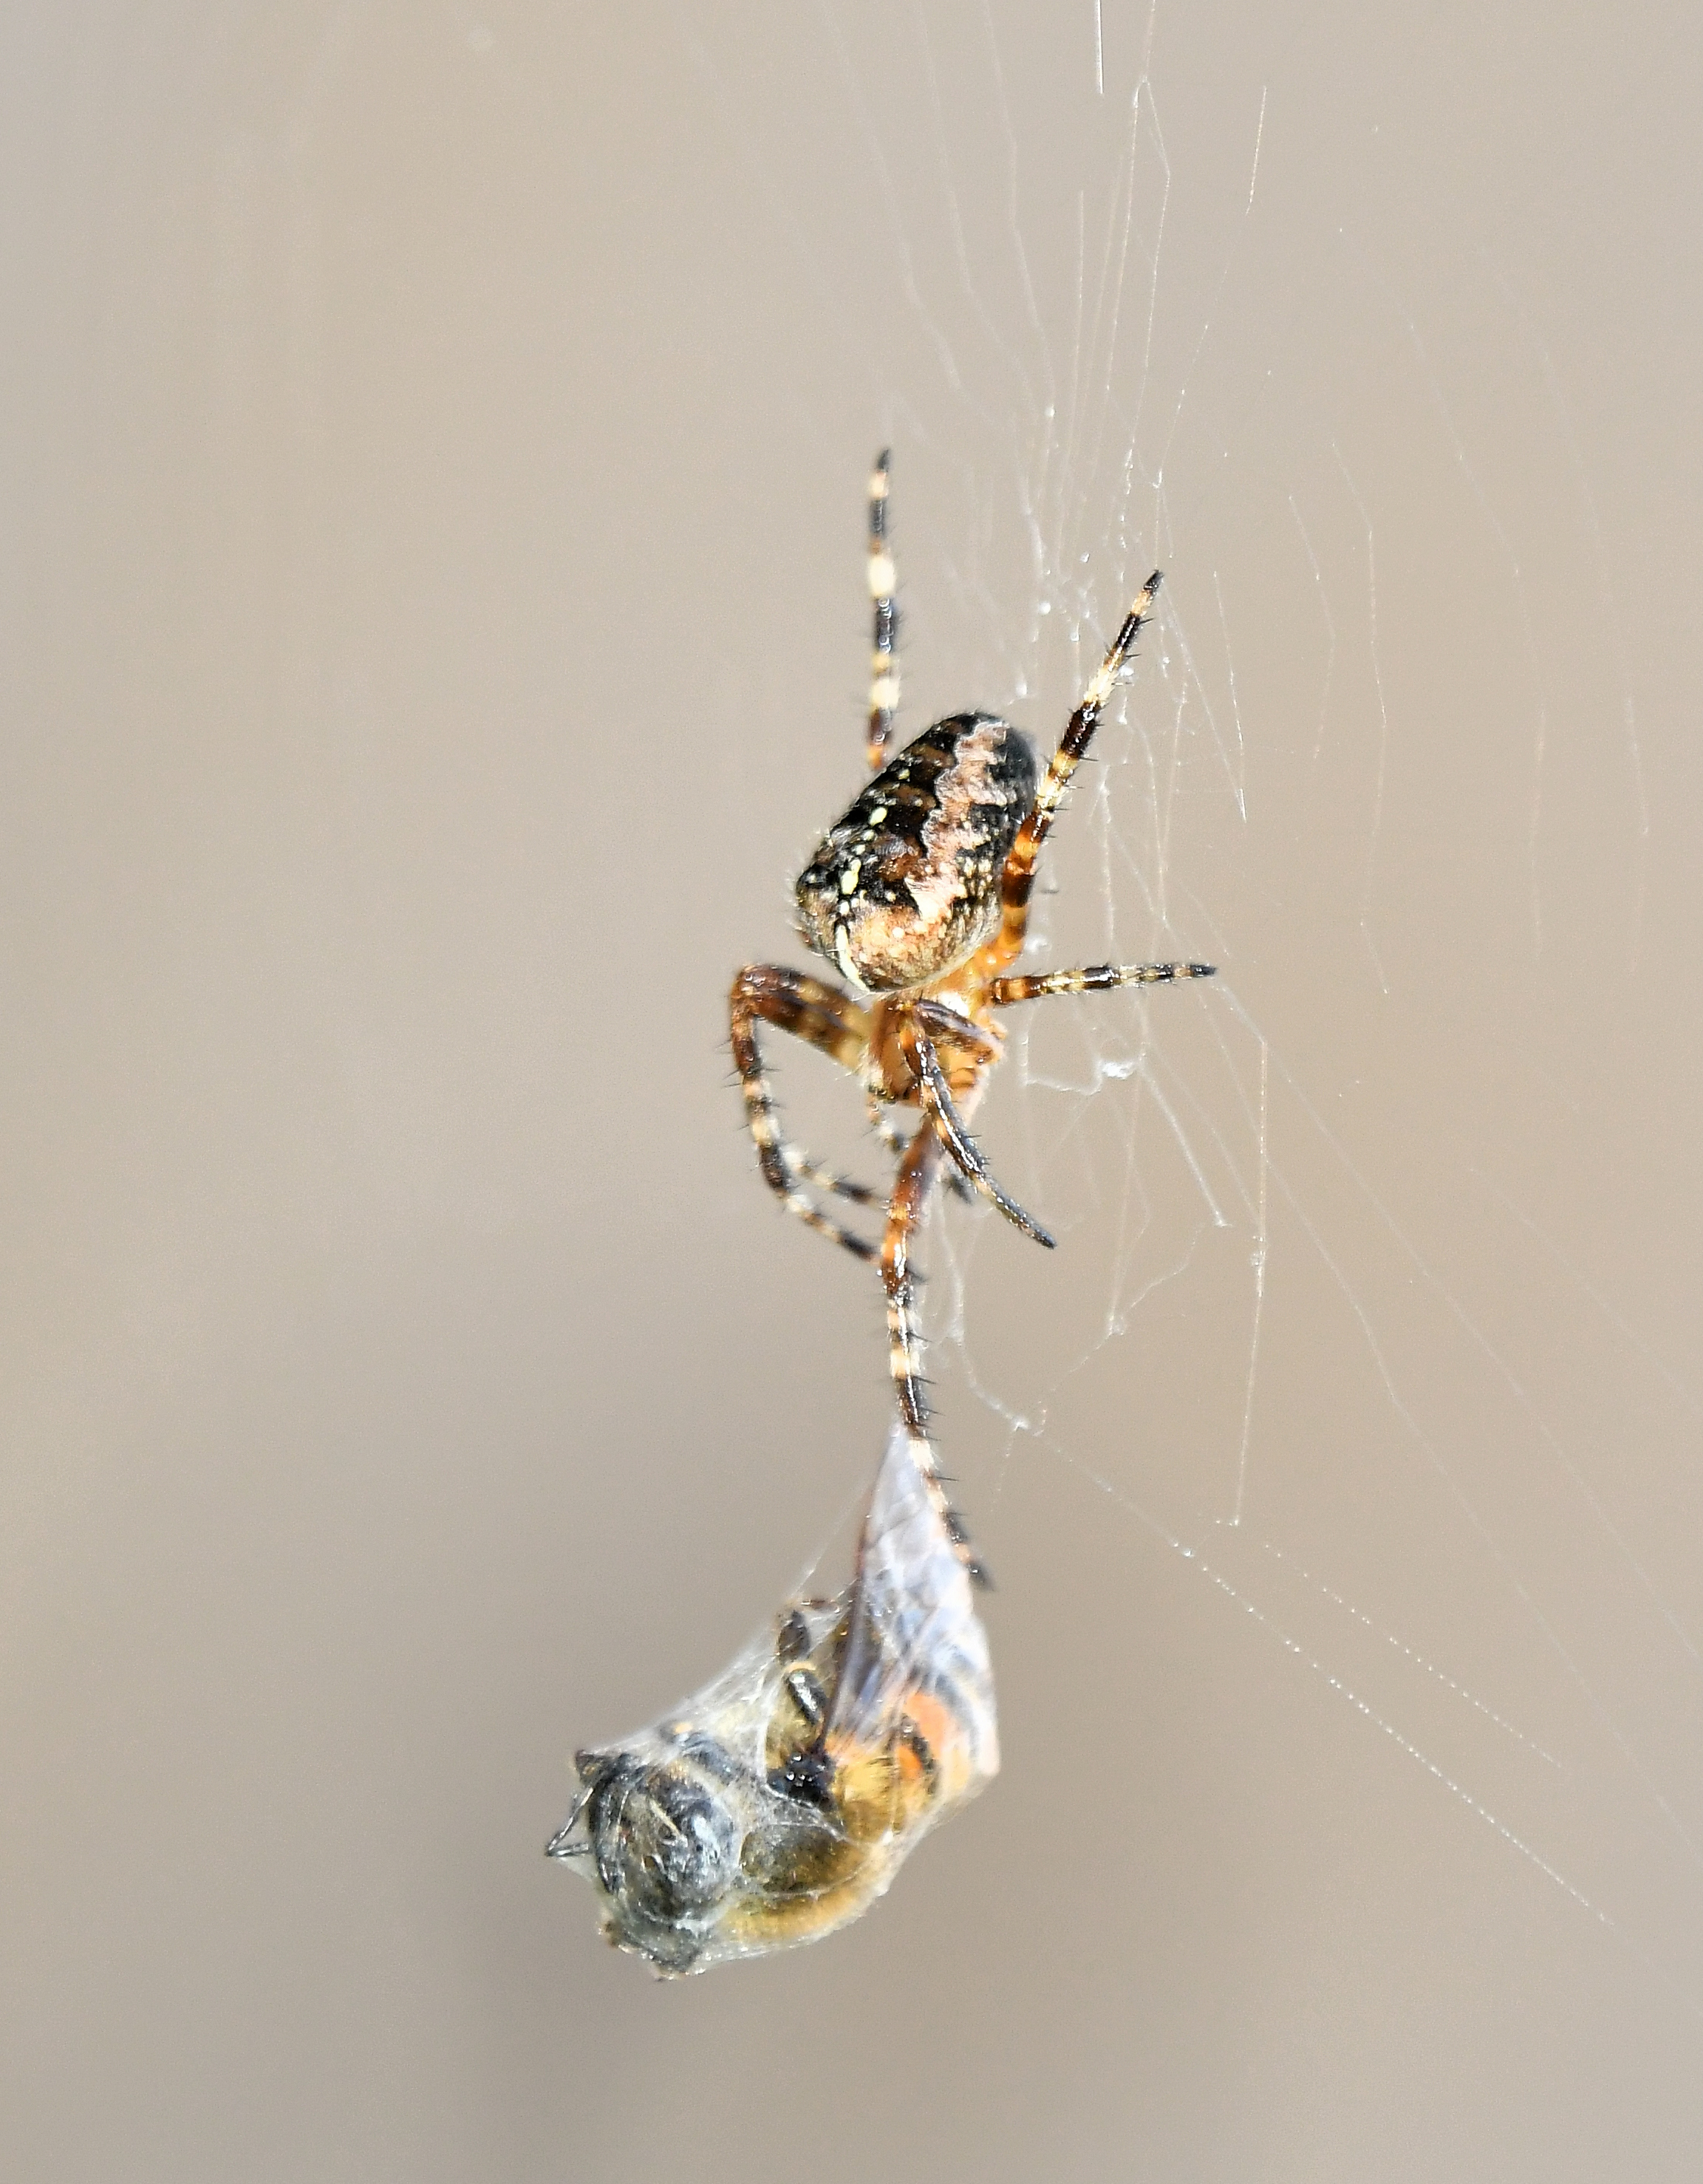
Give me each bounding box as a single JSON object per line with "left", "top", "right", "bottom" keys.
{"left": 827, "top": 1426, "right": 1000, "bottom": 1819}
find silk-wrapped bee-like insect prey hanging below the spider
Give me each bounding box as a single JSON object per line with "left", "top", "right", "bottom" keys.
{"left": 548, "top": 1428, "right": 1000, "bottom": 1974}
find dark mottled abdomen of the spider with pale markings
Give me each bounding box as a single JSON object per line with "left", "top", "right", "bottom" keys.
{"left": 797, "top": 712, "right": 1037, "bottom": 994}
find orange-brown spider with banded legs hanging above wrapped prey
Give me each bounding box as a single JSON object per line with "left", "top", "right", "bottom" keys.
{"left": 729, "top": 452, "right": 1216, "bottom": 1476}
